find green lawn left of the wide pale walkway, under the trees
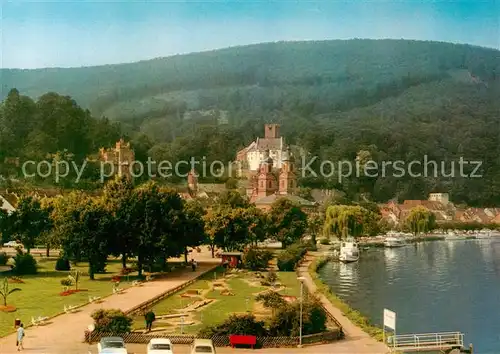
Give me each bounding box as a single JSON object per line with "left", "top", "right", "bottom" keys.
{"left": 0, "top": 258, "right": 136, "bottom": 337}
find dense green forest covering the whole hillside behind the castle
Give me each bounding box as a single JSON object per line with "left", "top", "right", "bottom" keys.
{"left": 0, "top": 40, "right": 500, "bottom": 206}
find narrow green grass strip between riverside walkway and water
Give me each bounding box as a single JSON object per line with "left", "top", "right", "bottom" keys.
{"left": 308, "top": 258, "right": 383, "bottom": 341}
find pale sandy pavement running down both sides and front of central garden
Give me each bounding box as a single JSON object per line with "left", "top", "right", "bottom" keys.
{"left": 0, "top": 252, "right": 389, "bottom": 354}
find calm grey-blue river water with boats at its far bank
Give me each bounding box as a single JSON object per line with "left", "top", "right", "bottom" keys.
{"left": 319, "top": 238, "right": 500, "bottom": 354}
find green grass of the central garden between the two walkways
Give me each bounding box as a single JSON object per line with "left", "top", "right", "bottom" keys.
{"left": 134, "top": 268, "right": 300, "bottom": 334}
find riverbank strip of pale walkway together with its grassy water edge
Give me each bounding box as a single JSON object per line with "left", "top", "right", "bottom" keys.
{"left": 297, "top": 252, "right": 389, "bottom": 354}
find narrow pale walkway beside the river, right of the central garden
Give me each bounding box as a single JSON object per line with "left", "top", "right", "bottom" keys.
{"left": 299, "top": 252, "right": 389, "bottom": 354}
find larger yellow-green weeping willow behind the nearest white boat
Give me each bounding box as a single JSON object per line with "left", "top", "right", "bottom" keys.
{"left": 323, "top": 205, "right": 366, "bottom": 239}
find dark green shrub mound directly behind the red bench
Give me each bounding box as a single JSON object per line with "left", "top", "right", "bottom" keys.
{"left": 198, "top": 314, "right": 267, "bottom": 338}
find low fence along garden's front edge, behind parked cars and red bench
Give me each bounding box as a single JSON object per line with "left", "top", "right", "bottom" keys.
{"left": 85, "top": 330, "right": 340, "bottom": 348}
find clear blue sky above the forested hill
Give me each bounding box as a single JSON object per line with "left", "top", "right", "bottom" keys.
{"left": 0, "top": 0, "right": 500, "bottom": 69}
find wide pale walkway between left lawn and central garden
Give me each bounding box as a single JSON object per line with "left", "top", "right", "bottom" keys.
{"left": 0, "top": 257, "right": 220, "bottom": 354}
